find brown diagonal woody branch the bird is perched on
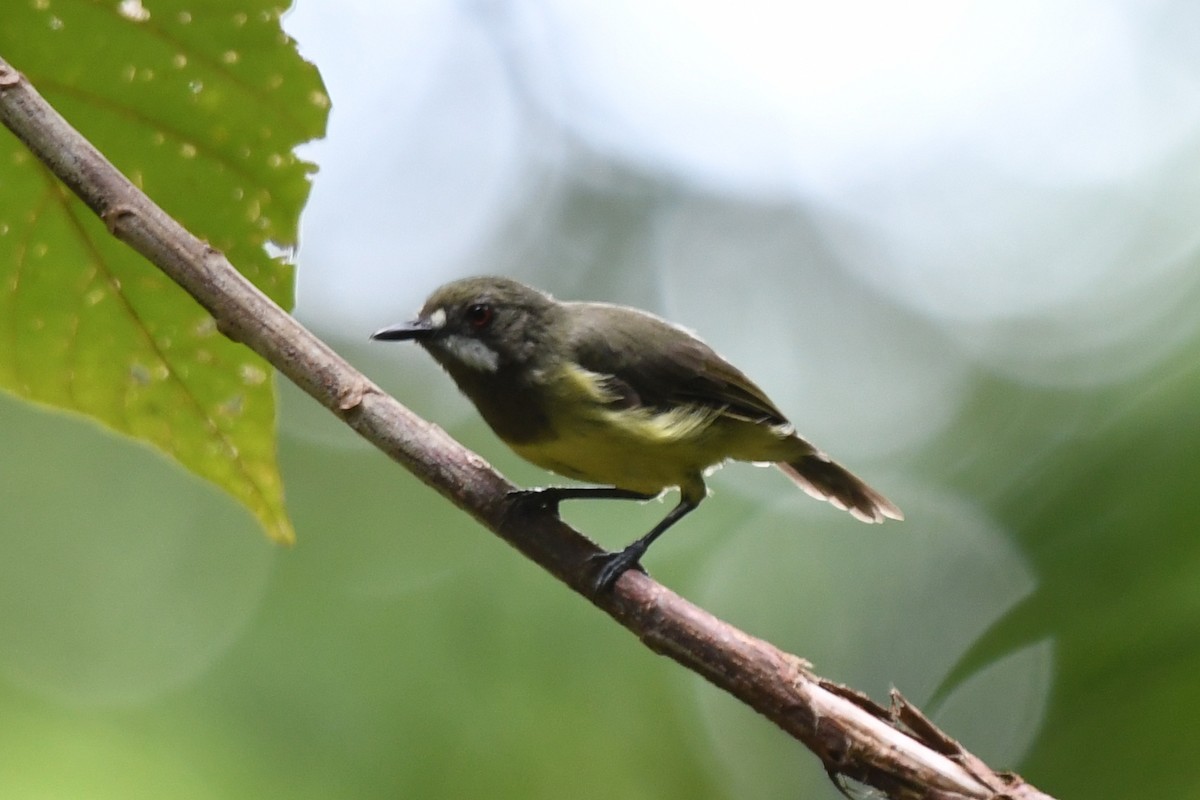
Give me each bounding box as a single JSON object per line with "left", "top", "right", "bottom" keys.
{"left": 0, "top": 59, "right": 1052, "bottom": 800}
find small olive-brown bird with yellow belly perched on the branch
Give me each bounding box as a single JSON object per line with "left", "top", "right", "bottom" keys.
{"left": 371, "top": 277, "right": 904, "bottom": 591}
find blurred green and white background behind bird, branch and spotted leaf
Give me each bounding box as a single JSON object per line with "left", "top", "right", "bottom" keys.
{"left": 0, "top": 0, "right": 1200, "bottom": 800}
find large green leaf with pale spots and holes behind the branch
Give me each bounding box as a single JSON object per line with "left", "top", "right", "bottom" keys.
{"left": 0, "top": 0, "right": 329, "bottom": 541}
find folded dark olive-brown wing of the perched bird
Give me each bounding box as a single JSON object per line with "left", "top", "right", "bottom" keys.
{"left": 570, "top": 303, "right": 787, "bottom": 425}
